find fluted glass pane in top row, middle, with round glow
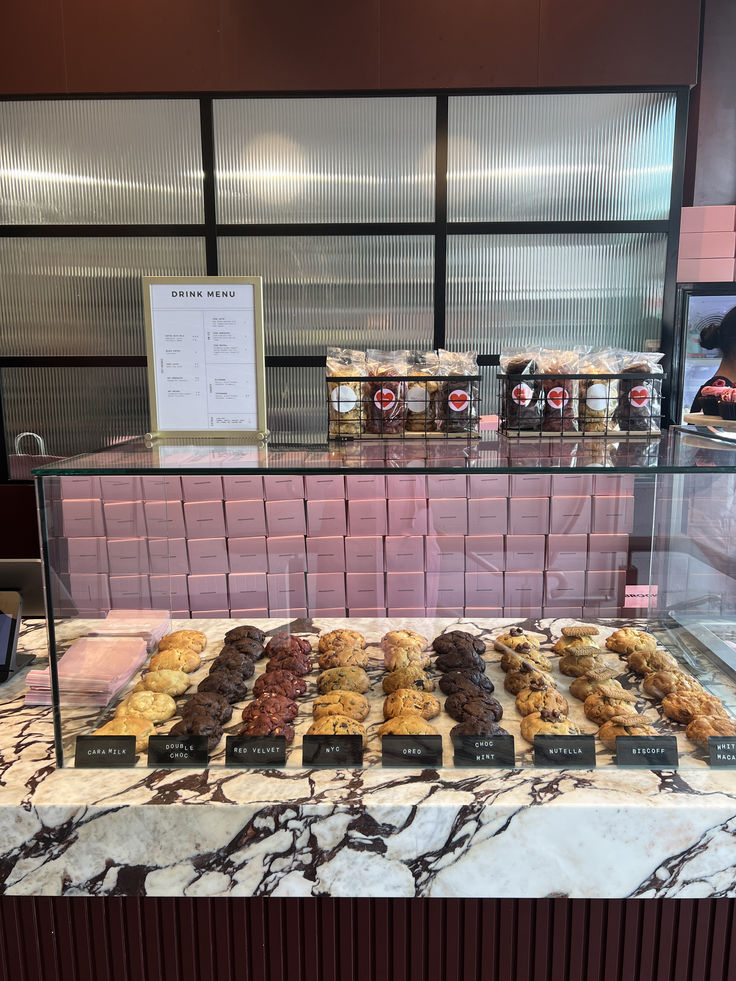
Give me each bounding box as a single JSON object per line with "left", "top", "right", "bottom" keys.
{"left": 214, "top": 98, "right": 435, "bottom": 224}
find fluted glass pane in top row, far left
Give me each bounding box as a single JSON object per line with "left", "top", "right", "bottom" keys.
{"left": 0, "top": 99, "right": 204, "bottom": 225}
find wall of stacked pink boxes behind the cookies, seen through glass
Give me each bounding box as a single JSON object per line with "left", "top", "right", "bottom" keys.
{"left": 54, "top": 472, "right": 634, "bottom": 618}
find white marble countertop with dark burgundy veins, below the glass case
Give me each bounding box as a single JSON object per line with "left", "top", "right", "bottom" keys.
{"left": 0, "top": 621, "right": 736, "bottom": 898}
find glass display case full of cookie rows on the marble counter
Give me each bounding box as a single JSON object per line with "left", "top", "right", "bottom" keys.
{"left": 27, "top": 431, "right": 736, "bottom": 768}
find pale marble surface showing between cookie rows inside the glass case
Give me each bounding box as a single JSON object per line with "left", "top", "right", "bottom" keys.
{"left": 57, "top": 618, "right": 736, "bottom": 770}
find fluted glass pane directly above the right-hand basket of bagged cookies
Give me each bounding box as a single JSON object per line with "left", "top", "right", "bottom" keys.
{"left": 447, "top": 233, "right": 667, "bottom": 353}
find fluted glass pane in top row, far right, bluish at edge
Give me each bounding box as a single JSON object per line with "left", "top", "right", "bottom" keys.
{"left": 447, "top": 92, "right": 675, "bottom": 221}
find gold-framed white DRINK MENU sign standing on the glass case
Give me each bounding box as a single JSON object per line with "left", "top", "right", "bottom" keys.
{"left": 143, "top": 276, "right": 267, "bottom": 439}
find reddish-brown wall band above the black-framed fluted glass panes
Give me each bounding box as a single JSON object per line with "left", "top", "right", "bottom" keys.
{"left": 0, "top": 0, "right": 700, "bottom": 94}
